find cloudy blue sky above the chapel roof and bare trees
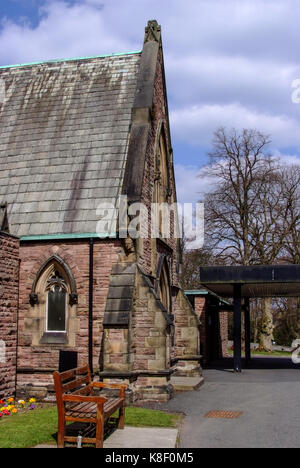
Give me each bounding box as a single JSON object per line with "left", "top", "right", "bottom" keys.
{"left": 0, "top": 0, "right": 300, "bottom": 201}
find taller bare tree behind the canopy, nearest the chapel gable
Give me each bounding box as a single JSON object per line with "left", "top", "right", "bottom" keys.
{"left": 204, "top": 128, "right": 275, "bottom": 265}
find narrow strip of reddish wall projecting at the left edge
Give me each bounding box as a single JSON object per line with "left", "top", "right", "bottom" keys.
{"left": 0, "top": 233, "right": 19, "bottom": 399}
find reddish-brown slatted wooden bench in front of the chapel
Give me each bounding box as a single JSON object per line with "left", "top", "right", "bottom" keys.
{"left": 53, "top": 365, "right": 127, "bottom": 448}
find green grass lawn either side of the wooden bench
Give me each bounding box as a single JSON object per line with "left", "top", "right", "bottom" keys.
{"left": 0, "top": 407, "right": 181, "bottom": 448}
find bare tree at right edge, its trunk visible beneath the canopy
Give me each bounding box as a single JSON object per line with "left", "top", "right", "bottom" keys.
{"left": 249, "top": 167, "right": 300, "bottom": 351}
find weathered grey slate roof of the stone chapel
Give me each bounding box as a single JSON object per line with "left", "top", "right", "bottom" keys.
{"left": 0, "top": 53, "right": 141, "bottom": 237}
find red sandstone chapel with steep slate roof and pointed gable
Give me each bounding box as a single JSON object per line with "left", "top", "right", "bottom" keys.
{"left": 0, "top": 21, "right": 201, "bottom": 401}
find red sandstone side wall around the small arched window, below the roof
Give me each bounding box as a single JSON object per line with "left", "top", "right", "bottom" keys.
{"left": 17, "top": 239, "right": 122, "bottom": 394}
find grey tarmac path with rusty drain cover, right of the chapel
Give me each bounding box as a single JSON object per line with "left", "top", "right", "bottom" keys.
{"left": 164, "top": 358, "right": 300, "bottom": 448}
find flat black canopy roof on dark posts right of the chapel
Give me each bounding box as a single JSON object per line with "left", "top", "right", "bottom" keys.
{"left": 200, "top": 265, "right": 300, "bottom": 298}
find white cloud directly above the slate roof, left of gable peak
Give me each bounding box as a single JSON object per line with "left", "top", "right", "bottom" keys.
{"left": 0, "top": 2, "right": 138, "bottom": 64}
